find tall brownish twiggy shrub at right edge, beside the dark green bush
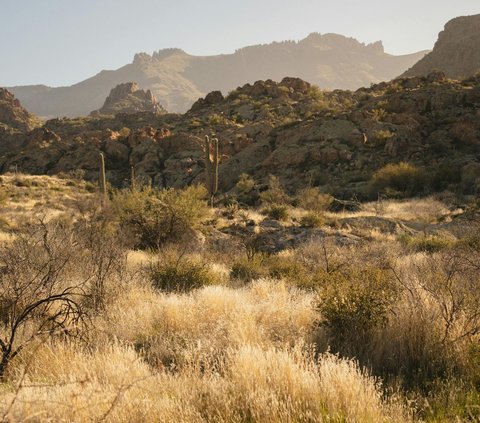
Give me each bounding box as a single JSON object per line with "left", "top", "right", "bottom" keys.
{"left": 368, "top": 250, "right": 480, "bottom": 393}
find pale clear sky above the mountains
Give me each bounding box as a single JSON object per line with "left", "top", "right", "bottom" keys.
{"left": 0, "top": 0, "right": 480, "bottom": 87}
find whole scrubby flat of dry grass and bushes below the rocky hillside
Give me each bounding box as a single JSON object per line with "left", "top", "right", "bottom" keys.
{"left": 0, "top": 175, "right": 480, "bottom": 422}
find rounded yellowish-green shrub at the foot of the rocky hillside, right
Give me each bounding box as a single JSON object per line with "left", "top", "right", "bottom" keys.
{"left": 370, "top": 162, "right": 426, "bottom": 197}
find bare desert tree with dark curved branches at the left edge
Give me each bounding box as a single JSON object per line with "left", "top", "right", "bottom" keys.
{"left": 0, "top": 222, "right": 87, "bottom": 378}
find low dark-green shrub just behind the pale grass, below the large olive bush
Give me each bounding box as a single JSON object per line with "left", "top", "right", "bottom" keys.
{"left": 147, "top": 251, "right": 220, "bottom": 292}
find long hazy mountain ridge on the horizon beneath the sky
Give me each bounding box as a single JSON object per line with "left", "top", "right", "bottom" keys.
{"left": 9, "top": 33, "right": 426, "bottom": 117}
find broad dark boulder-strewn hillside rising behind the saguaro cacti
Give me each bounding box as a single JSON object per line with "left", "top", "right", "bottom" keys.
{"left": 0, "top": 72, "right": 480, "bottom": 198}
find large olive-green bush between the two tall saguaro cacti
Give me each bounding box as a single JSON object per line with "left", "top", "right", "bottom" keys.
{"left": 113, "top": 186, "right": 208, "bottom": 248}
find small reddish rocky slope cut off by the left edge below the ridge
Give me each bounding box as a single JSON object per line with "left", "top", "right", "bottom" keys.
{"left": 0, "top": 88, "right": 41, "bottom": 131}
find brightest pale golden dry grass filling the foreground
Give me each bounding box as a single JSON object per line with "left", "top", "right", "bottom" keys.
{"left": 0, "top": 281, "right": 404, "bottom": 423}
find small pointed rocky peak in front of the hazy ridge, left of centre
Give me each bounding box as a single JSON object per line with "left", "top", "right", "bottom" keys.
{"left": 91, "top": 82, "right": 165, "bottom": 116}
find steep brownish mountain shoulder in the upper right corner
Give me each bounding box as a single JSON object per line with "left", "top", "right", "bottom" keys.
{"left": 403, "top": 15, "right": 480, "bottom": 78}
